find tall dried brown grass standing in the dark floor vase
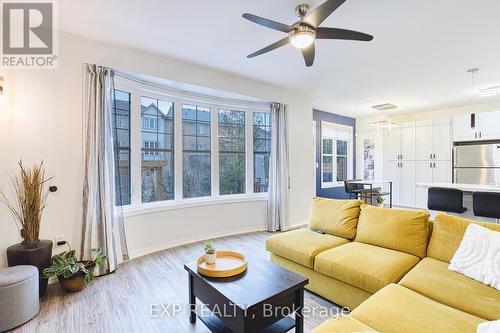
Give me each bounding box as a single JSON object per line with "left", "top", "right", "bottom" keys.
{"left": 0, "top": 161, "right": 52, "bottom": 243}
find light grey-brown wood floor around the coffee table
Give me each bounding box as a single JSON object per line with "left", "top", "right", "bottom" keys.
{"left": 13, "top": 232, "right": 339, "bottom": 333}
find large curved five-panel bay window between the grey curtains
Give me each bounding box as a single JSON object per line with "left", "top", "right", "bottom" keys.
{"left": 113, "top": 79, "right": 272, "bottom": 209}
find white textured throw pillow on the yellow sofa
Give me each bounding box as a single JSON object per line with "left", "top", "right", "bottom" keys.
{"left": 448, "top": 223, "right": 500, "bottom": 290}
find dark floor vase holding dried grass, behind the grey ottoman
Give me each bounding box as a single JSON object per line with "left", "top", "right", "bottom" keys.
{"left": 7, "top": 239, "right": 52, "bottom": 297}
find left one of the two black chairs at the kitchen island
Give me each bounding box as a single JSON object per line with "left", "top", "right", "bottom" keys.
{"left": 427, "top": 187, "right": 467, "bottom": 214}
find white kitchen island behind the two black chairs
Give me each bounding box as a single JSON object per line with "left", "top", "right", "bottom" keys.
{"left": 415, "top": 183, "right": 500, "bottom": 222}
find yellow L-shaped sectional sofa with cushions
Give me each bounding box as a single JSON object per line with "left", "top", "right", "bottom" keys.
{"left": 266, "top": 198, "right": 500, "bottom": 333}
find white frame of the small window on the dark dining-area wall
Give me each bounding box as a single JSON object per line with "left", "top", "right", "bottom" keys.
{"left": 320, "top": 121, "right": 354, "bottom": 189}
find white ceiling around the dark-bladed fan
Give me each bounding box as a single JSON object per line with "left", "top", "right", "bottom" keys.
{"left": 58, "top": 0, "right": 500, "bottom": 116}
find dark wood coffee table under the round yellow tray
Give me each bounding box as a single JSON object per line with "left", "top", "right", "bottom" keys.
{"left": 184, "top": 257, "right": 309, "bottom": 333}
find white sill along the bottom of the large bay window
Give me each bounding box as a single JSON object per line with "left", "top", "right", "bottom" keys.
{"left": 123, "top": 193, "right": 268, "bottom": 218}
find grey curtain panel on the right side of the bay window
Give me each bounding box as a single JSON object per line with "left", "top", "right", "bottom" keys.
{"left": 267, "top": 103, "right": 290, "bottom": 231}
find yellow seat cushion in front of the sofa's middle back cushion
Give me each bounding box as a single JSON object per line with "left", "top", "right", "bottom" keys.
{"left": 314, "top": 242, "right": 419, "bottom": 293}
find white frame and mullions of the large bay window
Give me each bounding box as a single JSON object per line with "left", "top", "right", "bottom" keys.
{"left": 115, "top": 76, "right": 271, "bottom": 211}
